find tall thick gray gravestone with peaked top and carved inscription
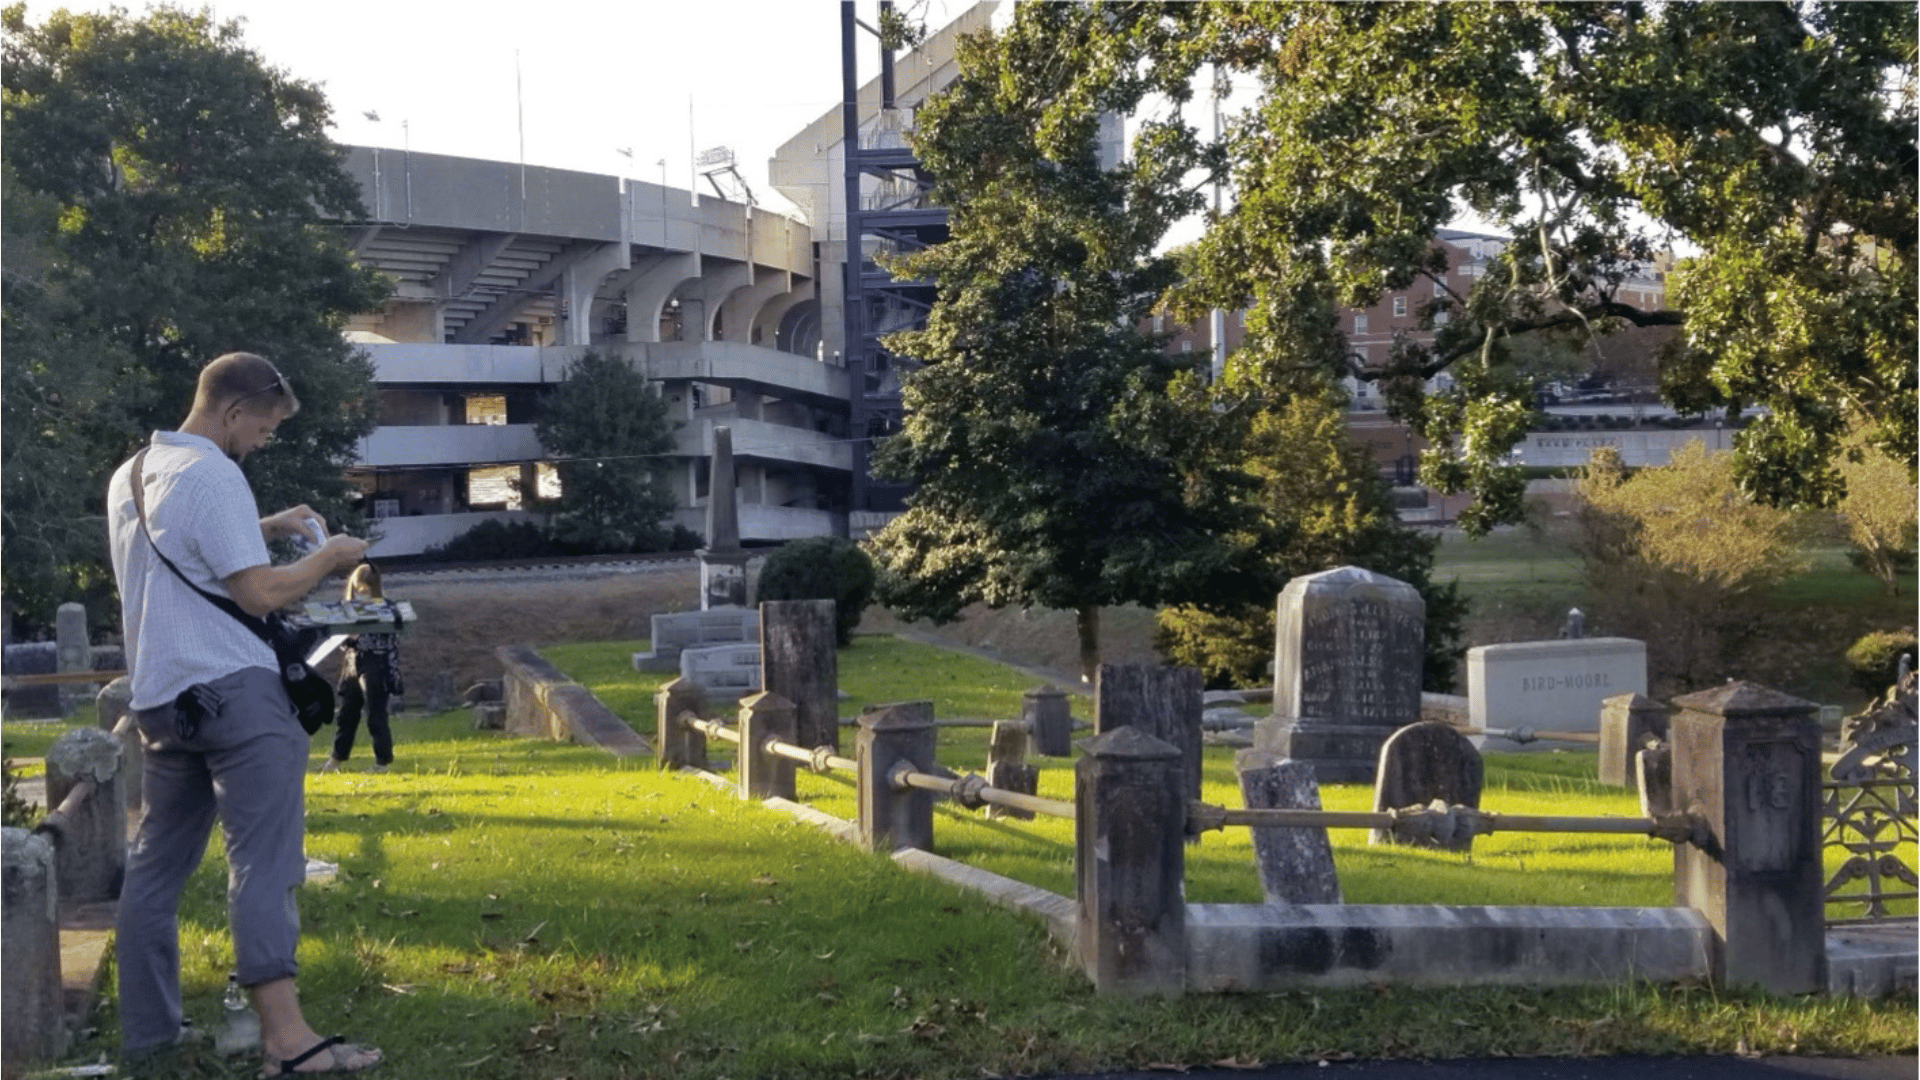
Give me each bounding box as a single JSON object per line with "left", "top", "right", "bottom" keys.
{"left": 1254, "top": 567, "right": 1427, "bottom": 784}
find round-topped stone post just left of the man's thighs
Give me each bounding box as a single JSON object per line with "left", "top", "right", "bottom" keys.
{"left": 36, "top": 728, "right": 127, "bottom": 903}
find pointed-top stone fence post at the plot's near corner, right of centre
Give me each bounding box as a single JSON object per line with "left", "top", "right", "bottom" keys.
{"left": 1073, "top": 724, "right": 1187, "bottom": 995}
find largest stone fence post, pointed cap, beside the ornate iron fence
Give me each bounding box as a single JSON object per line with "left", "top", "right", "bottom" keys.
{"left": 1670, "top": 682, "right": 1826, "bottom": 994}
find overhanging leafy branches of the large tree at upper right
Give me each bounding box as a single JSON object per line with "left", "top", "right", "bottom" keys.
{"left": 983, "top": 0, "right": 1920, "bottom": 530}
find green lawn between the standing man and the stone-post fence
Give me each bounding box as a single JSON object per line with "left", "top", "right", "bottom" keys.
{"left": 69, "top": 713, "right": 1914, "bottom": 1080}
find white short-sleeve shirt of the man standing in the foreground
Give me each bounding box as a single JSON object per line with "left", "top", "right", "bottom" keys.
{"left": 108, "top": 430, "right": 275, "bottom": 709}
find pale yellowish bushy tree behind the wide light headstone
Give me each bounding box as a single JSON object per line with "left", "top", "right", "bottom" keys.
{"left": 1572, "top": 438, "right": 1812, "bottom": 690}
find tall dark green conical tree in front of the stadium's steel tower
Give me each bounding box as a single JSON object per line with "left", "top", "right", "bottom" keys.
{"left": 874, "top": 4, "right": 1229, "bottom": 678}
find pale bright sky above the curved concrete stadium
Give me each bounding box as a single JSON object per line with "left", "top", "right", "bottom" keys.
{"left": 27, "top": 0, "right": 972, "bottom": 219}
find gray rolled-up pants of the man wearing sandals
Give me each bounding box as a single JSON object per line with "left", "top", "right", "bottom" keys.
{"left": 113, "top": 667, "right": 307, "bottom": 1057}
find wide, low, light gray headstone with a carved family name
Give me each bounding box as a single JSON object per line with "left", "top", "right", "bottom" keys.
{"left": 1467, "top": 638, "right": 1647, "bottom": 737}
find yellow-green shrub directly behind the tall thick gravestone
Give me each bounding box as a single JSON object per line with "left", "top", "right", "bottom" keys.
{"left": 1154, "top": 398, "right": 1467, "bottom": 692}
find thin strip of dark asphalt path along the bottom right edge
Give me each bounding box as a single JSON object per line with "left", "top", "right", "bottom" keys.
{"left": 1035, "top": 1055, "right": 1920, "bottom": 1080}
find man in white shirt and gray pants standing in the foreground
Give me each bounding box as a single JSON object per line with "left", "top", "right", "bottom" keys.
{"left": 108, "top": 352, "right": 380, "bottom": 1076}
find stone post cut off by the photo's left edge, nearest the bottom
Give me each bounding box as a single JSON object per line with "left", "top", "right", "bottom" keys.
{"left": 0, "top": 826, "right": 67, "bottom": 1076}
